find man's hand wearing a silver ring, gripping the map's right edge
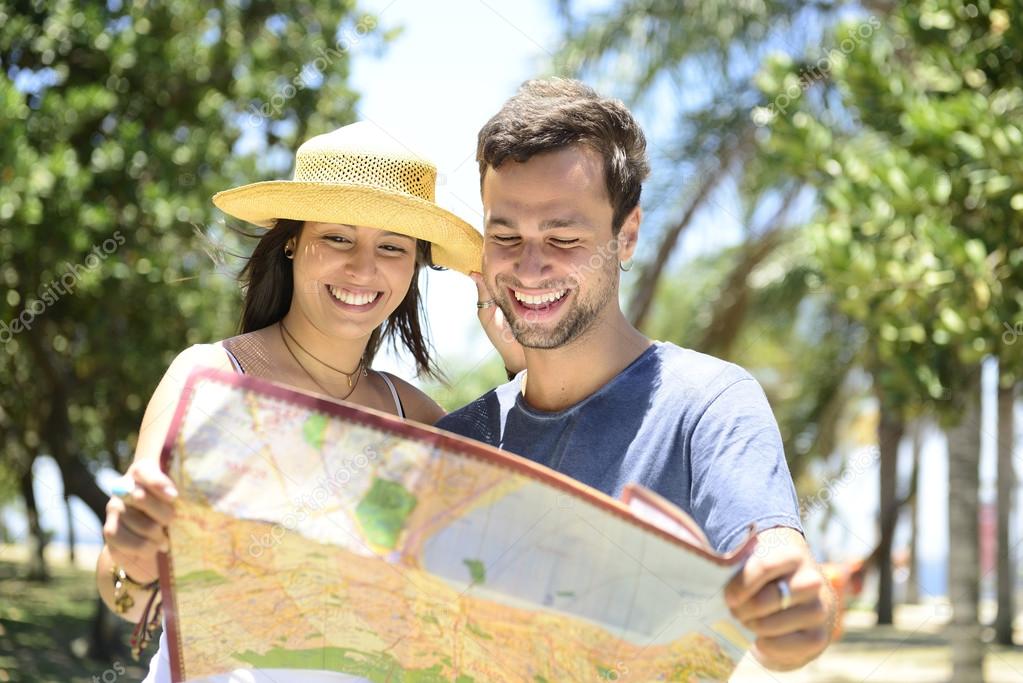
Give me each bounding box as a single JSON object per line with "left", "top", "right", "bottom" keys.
{"left": 724, "top": 527, "right": 836, "bottom": 671}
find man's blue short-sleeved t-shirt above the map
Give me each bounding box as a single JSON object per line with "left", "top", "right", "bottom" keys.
{"left": 437, "top": 342, "right": 802, "bottom": 552}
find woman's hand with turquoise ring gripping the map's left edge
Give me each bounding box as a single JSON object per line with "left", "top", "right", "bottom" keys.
{"left": 103, "top": 460, "right": 178, "bottom": 584}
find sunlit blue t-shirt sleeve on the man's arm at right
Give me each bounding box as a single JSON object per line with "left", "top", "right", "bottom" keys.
{"left": 690, "top": 377, "right": 803, "bottom": 552}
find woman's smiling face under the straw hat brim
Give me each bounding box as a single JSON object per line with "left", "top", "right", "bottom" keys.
{"left": 292, "top": 221, "right": 416, "bottom": 339}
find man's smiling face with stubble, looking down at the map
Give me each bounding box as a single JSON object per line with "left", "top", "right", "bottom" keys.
{"left": 483, "top": 144, "right": 634, "bottom": 349}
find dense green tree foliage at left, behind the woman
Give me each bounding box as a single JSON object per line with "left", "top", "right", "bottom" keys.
{"left": 0, "top": 0, "right": 384, "bottom": 496}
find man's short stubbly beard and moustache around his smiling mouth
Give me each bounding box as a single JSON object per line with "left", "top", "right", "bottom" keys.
{"left": 496, "top": 269, "right": 615, "bottom": 349}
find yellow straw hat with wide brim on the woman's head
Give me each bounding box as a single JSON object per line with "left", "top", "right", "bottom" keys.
{"left": 213, "top": 122, "right": 483, "bottom": 274}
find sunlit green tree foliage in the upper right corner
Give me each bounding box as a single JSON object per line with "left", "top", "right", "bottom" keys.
{"left": 759, "top": 1, "right": 1023, "bottom": 419}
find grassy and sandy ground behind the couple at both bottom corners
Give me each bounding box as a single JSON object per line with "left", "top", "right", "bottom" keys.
{"left": 0, "top": 557, "right": 1023, "bottom": 683}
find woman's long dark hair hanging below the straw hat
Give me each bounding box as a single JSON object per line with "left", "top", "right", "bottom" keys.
{"left": 238, "top": 219, "right": 442, "bottom": 378}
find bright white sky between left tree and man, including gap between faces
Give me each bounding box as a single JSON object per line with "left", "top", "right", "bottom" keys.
{"left": 352, "top": 0, "right": 559, "bottom": 378}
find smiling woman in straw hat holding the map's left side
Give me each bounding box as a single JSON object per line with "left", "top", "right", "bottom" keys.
{"left": 96, "top": 123, "right": 521, "bottom": 681}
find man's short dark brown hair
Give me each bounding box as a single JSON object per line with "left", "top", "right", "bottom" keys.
{"left": 476, "top": 78, "right": 650, "bottom": 235}
